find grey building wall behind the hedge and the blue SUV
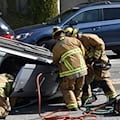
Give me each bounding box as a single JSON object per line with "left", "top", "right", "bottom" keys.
{"left": 0, "top": 0, "right": 120, "bottom": 15}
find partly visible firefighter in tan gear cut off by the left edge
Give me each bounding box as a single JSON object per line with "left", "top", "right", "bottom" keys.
{"left": 0, "top": 73, "right": 13, "bottom": 118}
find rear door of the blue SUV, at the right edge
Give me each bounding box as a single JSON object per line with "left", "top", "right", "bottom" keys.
{"left": 100, "top": 7, "right": 120, "bottom": 48}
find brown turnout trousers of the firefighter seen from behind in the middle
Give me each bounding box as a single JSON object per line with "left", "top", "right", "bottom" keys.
{"left": 60, "top": 76, "right": 85, "bottom": 109}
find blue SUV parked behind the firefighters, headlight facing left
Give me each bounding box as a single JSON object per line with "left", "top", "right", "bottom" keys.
{"left": 15, "top": 1, "right": 120, "bottom": 54}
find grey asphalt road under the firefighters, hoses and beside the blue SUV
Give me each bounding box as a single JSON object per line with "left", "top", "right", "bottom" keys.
{"left": 5, "top": 53, "right": 120, "bottom": 120}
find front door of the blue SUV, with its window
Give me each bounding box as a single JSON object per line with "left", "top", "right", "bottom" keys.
{"left": 64, "top": 9, "right": 102, "bottom": 35}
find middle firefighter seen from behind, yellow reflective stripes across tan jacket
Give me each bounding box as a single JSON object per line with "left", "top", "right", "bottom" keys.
{"left": 52, "top": 27, "right": 87, "bottom": 111}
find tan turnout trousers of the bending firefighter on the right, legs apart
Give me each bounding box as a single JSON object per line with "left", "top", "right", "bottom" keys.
{"left": 82, "top": 67, "right": 117, "bottom": 99}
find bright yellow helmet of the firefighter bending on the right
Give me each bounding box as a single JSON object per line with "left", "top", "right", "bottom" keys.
{"left": 64, "top": 27, "right": 78, "bottom": 37}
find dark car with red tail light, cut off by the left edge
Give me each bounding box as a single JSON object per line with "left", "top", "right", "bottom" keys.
{"left": 0, "top": 17, "right": 15, "bottom": 39}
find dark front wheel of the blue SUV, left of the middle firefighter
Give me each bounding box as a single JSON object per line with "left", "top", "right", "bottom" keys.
{"left": 37, "top": 38, "right": 56, "bottom": 51}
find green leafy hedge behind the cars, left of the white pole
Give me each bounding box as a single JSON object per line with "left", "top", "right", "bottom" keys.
{"left": 2, "top": 0, "right": 58, "bottom": 29}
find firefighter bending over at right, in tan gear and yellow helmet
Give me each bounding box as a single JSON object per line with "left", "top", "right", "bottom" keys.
{"left": 64, "top": 27, "right": 116, "bottom": 102}
